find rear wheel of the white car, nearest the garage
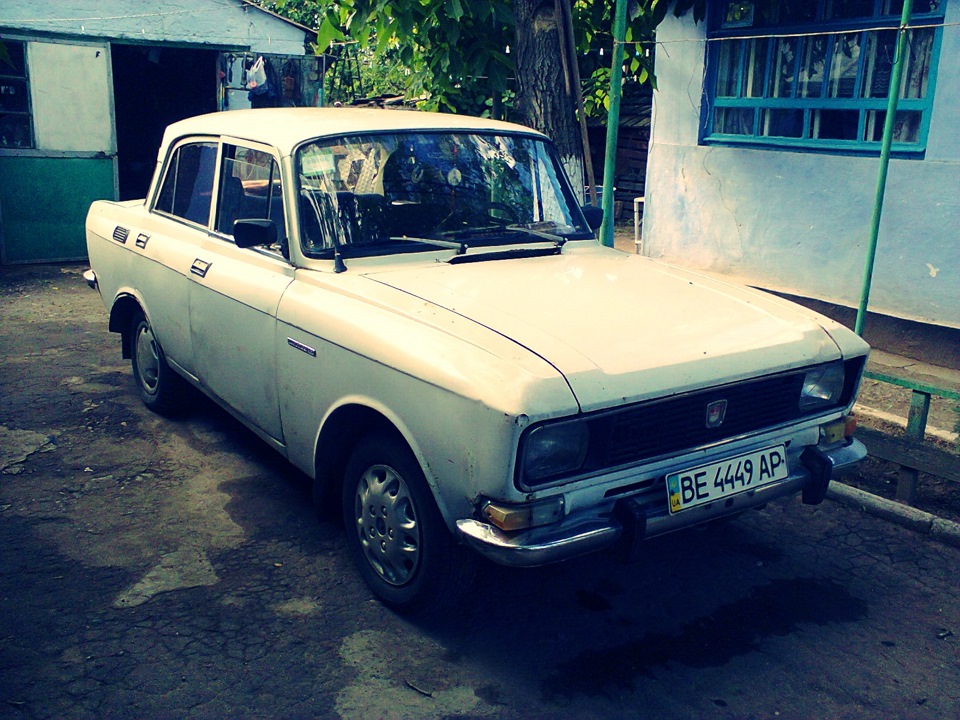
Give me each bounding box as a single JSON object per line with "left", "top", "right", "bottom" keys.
{"left": 130, "top": 310, "right": 190, "bottom": 415}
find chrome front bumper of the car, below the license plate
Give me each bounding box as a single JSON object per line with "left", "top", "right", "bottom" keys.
{"left": 457, "top": 438, "right": 867, "bottom": 567}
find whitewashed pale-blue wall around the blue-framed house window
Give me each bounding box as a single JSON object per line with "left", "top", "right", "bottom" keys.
{"left": 643, "top": 2, "right": 960, "bottom": 327}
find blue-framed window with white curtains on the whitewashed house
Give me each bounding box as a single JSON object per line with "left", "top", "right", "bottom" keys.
{"left": 701, "top": 0, "right": 946, "bottom": 154}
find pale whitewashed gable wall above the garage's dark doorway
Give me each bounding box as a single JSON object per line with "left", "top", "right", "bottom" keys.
{"left": 0, "top": 0, "right": 304, "bottom": 55}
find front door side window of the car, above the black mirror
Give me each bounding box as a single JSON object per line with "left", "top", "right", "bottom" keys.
{"left": 216, "top": 145, "right": 286, "bottom": 241}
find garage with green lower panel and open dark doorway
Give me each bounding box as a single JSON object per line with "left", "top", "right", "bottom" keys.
{"left": 0, "top": 0, "right": 322, "bottom": 263}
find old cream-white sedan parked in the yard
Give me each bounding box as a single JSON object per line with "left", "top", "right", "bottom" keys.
{"left": 87, "top": 109, "right": 868, "bottom": 611}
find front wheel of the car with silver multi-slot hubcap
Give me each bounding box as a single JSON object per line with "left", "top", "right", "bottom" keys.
{"left": 343, "top": 434, "right": 476, "bottom": 614}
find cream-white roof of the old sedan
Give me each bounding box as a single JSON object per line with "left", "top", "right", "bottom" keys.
{"left": 161, "top": 108, "right": 543, "bottom": 155}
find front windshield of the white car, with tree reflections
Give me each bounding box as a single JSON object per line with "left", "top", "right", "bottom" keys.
{"left": 297, "top": 132, "right": 593, "bottom": 258}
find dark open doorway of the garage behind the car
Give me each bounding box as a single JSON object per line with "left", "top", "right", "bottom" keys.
{"left": 110, "top": 44, "right": 218, "bottom": 200}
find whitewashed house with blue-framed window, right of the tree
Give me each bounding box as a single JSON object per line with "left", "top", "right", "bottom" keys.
{"left": 643, "top": 0, "right": 960, "bottom": 328}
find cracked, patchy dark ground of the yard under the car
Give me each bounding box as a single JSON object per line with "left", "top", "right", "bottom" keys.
{"left": 0, "top": 265, "right": 960, "bottom": 720}
